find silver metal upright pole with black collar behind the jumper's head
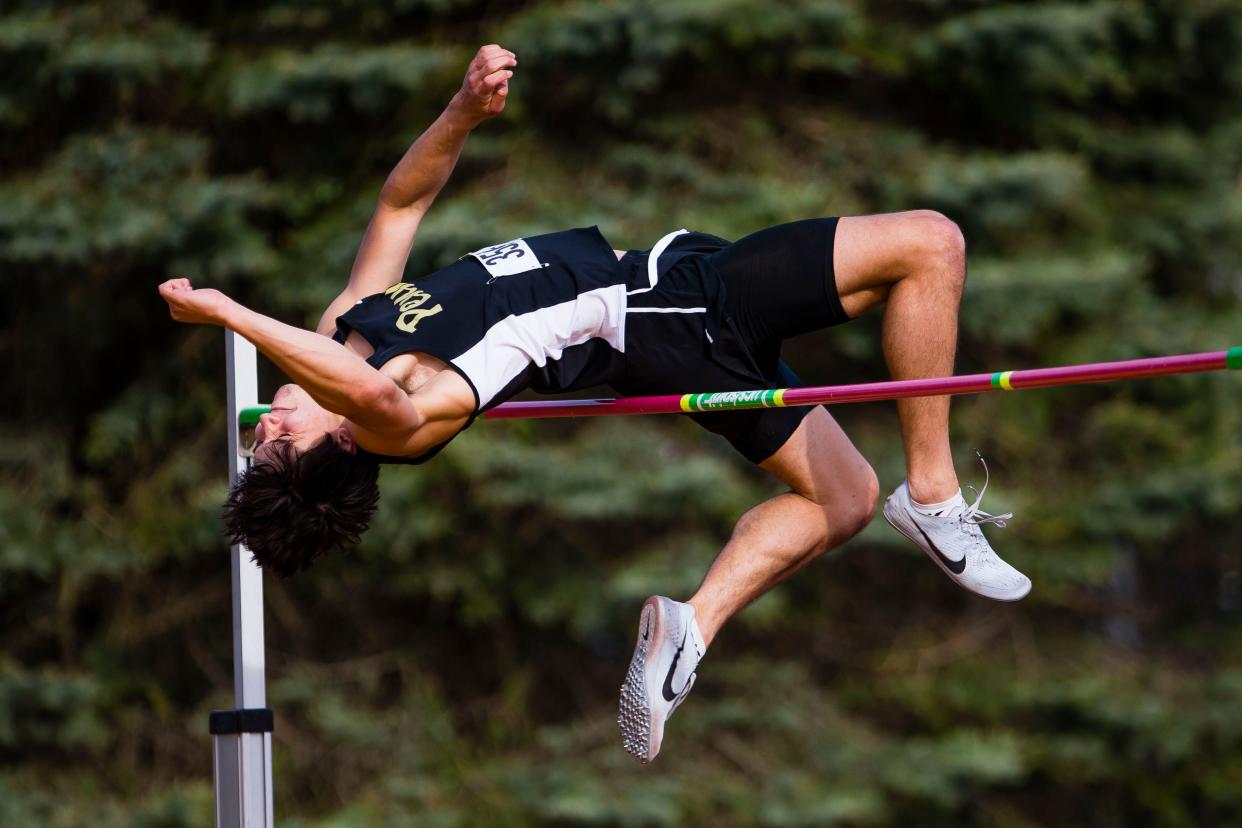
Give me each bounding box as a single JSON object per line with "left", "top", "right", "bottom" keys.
{"left": 209, "top": 330, "right": 276, "bottom": 828}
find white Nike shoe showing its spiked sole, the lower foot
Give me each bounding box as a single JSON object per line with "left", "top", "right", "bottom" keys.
{"left": 617, "top": 595, "right": 707, "bottom": 765}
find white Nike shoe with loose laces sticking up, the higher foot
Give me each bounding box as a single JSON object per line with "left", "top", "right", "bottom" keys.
{"left": 884, "top": 458, "right": 1031, "bottom": 601}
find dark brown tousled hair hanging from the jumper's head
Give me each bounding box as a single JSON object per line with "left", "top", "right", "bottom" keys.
{"left": 224, "top": 437, "right": 380, "bottom": 577}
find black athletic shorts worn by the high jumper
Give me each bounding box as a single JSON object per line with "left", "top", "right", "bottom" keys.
{"left": 627, "top": 218, "right": 848, "bottom": 464}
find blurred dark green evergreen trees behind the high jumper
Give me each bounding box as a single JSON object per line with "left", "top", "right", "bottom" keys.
{"left": 0, "top": 0, "right": 1242, "bottom": 828}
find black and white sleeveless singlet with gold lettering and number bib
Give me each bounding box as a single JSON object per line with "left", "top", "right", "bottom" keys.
{"left": 334, "top": 227, "right": 727, "bottom": 463}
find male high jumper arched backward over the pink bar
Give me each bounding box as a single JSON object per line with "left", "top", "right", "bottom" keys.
{"left": 159, "top": 45, "right": 1031, "bottom": 762}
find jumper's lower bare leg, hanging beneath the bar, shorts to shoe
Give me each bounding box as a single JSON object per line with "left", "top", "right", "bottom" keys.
{"left": 689, "top": 408, "right": 879, "bottom": 644}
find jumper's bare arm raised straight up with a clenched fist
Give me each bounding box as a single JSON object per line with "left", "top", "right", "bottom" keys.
{"left": 315, "top": 43, "right": 518, "bottom": 336}
